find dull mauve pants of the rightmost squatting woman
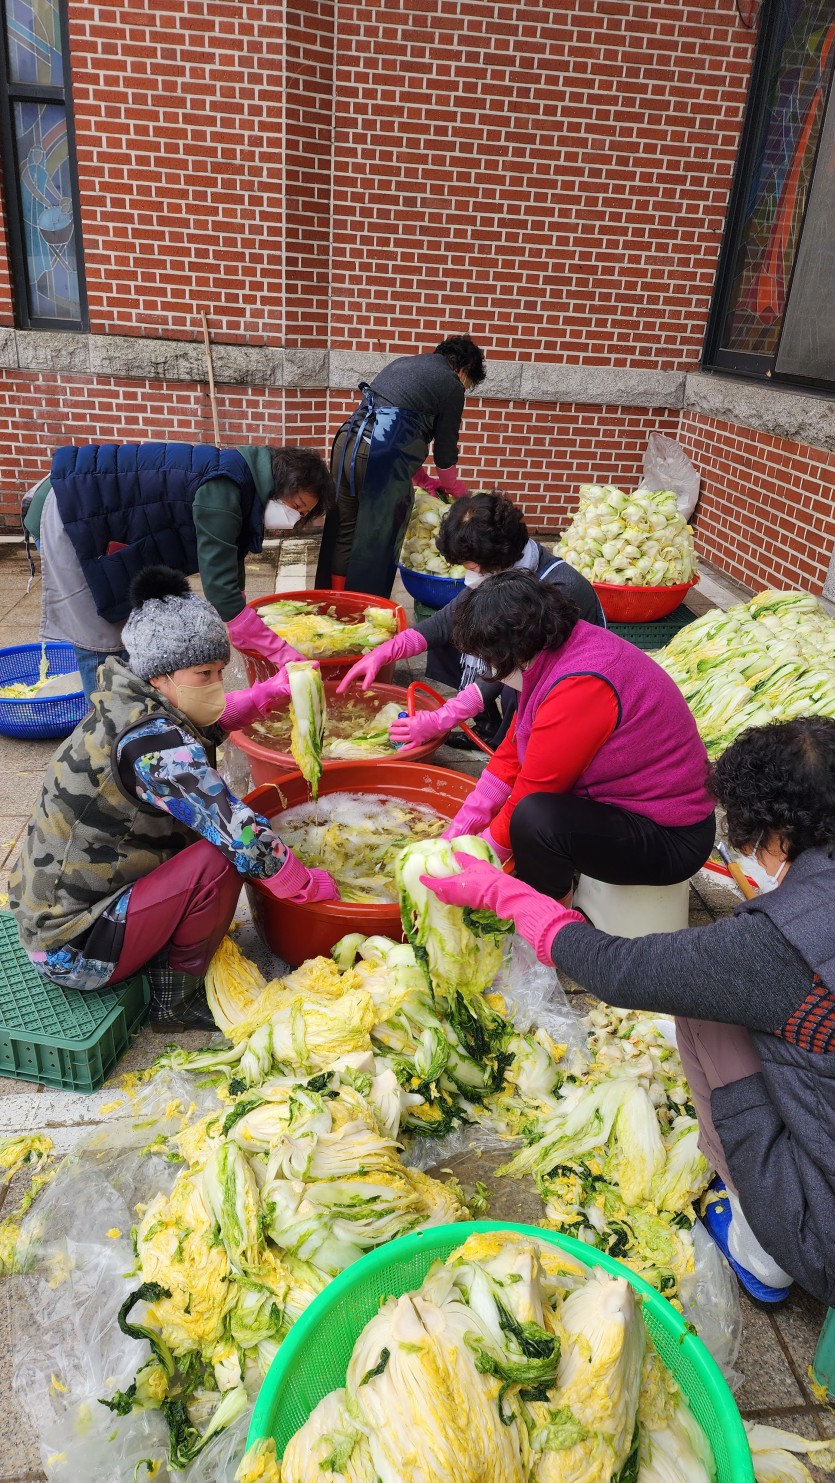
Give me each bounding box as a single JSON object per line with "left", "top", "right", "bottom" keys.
{"left": 675, "top": 1019, "right": 762, "bottom": 1194}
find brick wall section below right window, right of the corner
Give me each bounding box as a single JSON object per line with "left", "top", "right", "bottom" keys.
{"left": 679, "top": 412, "right": 835, "bottom": 593}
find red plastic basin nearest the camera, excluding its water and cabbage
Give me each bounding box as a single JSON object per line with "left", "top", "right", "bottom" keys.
{"left": 245, "top": 761, "right": 476, "bottom": 967}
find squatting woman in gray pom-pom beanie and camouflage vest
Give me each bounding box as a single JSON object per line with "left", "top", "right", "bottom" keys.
{"left": 9, "top": 567, "right": 338, "bottom": 1031}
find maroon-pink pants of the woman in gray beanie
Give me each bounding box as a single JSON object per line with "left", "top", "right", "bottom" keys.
{"left": 111, "top": 839, "right": 243, "bottom": 983}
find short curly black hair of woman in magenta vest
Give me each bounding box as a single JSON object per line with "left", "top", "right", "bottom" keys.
{"left": 452, "top": 571, "right": 580, "bottom": 679}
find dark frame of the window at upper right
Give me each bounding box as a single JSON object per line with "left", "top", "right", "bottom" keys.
{"left": 702, "top": 0, "right": 835, "bottom": 393}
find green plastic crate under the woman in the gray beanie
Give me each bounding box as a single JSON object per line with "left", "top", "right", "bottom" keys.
{"left": 0, "top": 912, "right": 151, "bottom": 1091}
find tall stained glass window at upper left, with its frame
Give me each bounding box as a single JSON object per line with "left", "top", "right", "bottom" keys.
{"left": 0, "top": 0, "right": 85, "bottom": 329}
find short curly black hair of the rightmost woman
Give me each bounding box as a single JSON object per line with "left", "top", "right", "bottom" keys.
{"left": 710, "top": 716, "right": 835, "bottom": 860}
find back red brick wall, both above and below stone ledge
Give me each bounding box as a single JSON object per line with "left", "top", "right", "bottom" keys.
{"left": 0, "top": 0, "right": 783, "bottom": 578}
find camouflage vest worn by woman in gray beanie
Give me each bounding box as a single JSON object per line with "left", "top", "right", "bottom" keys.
{"left": 9, "top": 658, "right": 215, "bottom": 952}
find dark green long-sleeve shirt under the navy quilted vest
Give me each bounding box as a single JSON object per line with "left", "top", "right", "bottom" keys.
{"left": 24, "top": 446, "right": 274, "bottom": 623}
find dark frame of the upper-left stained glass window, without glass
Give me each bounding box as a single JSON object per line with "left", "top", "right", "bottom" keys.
{"left": 0, "top": 0, "right": 89, "bottom": 334}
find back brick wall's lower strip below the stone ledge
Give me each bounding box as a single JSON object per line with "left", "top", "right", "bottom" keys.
{"left": 0, "top": 374, "right": 679, "bottom": 531}
